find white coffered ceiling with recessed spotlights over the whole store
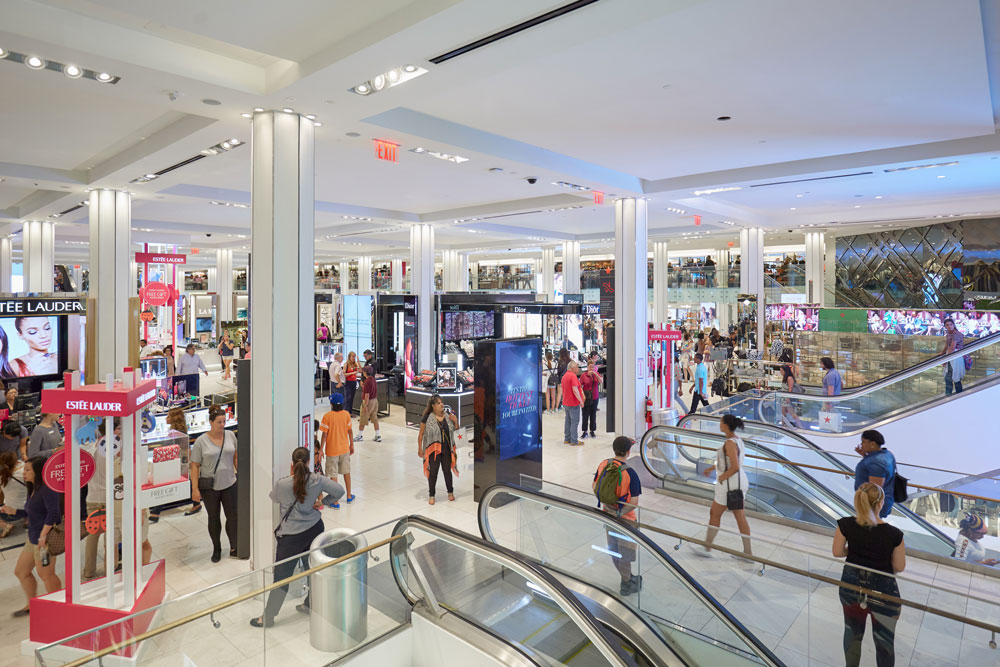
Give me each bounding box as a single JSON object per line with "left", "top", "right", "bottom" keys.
{"left": 0, "top": 0, "right": 1000, "bottom": 259}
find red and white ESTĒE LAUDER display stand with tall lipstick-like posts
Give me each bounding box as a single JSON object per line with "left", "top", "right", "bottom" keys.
{"left": 22, "top": 368, "right": 166, "bottom": 658}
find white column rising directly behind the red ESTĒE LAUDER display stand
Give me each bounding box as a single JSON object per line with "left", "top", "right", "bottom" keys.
{"left": 87, "top": 190, "right": 135, "bottom": 380}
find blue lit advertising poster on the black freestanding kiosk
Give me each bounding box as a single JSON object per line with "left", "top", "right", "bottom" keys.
{"left": 496, "top": 338, "right": 542, "bottom": 461}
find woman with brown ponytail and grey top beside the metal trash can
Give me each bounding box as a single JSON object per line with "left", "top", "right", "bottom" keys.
{"left": 250, "top": 447, "right": 344, "bottom": 628}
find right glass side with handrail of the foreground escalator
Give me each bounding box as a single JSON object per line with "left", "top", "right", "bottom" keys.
{"left": 479, "top": 484, "right": 783, "bottom": 665}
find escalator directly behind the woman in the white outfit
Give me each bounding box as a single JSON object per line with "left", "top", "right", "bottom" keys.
{"left": 640, "top": 415, "right": 954, "bottom": 556}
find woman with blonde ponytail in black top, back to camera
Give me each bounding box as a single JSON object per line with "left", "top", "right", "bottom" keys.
{"left": 833, "top": 482, "right": 906, "bottom": 667}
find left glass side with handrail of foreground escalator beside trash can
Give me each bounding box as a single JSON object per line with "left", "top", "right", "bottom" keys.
{"left": 391, "top": 516, "right": 781, "bottom": 667}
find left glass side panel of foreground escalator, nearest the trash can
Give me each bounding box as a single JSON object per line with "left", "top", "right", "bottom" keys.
{"left": 394, "top": 524, "right": 616, "bottom": 665}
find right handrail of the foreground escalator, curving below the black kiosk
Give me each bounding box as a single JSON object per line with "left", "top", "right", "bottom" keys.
{"left": 478, "top": 482, "right": 784, "bottom": 666}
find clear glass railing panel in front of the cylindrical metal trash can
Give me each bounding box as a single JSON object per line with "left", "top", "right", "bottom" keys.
{"left": 36, "top": 522, "right": 410, "bottom": 667}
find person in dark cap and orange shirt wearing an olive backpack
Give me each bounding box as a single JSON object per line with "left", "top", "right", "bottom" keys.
{"left": 593, "top": 435, "right": 642, "bottom": 595}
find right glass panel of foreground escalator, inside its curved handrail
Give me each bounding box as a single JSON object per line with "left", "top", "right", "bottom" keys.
{"left": 481, "top": 491, "right": 772, "bottom": 665}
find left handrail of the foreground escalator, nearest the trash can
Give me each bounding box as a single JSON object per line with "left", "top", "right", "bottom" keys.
{"left": 390, "top": 514, "right": 636, "bottom": 665}
